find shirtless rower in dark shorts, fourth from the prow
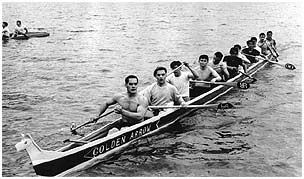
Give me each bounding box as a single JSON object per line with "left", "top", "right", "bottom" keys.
{"left": 190, "top": 55, "right": 222, "bottom": 97}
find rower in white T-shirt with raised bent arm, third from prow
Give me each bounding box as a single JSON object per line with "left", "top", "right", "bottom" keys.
{"left": 166, "top": 61, "right": 198, "bottom": 101}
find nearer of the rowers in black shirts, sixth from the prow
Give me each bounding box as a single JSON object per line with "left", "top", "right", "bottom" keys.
{"left": 223, "top": 47, "right": 247, "bottom": 78}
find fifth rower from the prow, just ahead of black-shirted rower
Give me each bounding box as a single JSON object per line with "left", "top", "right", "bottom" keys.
{"left": 209, "top": 52, "right": 229, "bottom": 81}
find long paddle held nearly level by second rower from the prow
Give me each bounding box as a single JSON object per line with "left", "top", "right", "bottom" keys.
{"left": 149, "top": 103, "right": 234, "bottom": 109}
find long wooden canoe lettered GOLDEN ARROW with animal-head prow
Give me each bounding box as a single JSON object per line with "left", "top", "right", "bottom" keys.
{"left": 16, "top": 57, "right": 269, "bottom": 176}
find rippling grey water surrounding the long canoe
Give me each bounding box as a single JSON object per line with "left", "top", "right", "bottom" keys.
{"left": 2, "top": 2, "right": 302, "bottom": 177}
